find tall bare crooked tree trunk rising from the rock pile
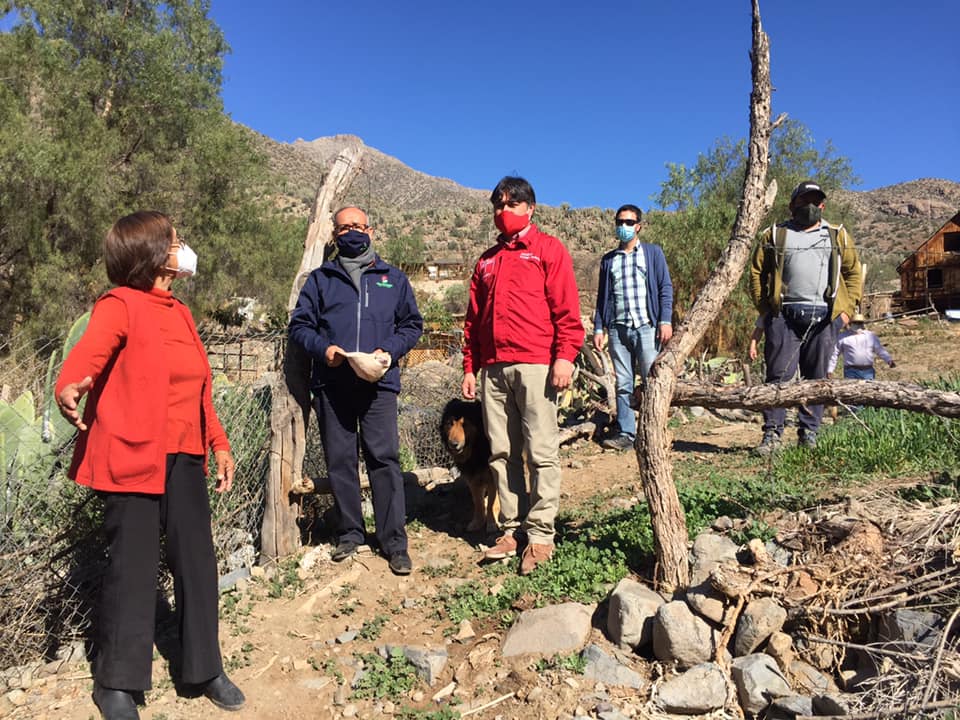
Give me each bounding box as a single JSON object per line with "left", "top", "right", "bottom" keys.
{"left": 635, "top": 0, "right": 776, "bottom": 591}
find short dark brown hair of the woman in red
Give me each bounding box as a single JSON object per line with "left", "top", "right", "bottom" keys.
{"left": 103, "top": 210, "right": 173, "bottom": 290}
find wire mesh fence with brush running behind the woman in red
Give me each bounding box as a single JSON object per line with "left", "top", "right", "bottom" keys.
{"left": 0, "top": 323, "right": 459, "bottom": 668}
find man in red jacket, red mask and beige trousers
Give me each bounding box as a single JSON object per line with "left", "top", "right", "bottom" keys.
{"left": 462, "top": 177, "right": 583, "bottom": 575}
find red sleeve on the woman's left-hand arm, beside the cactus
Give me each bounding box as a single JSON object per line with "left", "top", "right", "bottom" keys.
{"left": 54, "top": 297, "right": 129, "bottom": 395}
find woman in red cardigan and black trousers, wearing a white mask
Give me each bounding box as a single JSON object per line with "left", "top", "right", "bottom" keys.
{"left": 56, "top": 211, "right": 244, "bottom": 720}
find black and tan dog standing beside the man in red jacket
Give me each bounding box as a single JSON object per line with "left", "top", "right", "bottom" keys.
{"left": 440, "top": 400, "right": 500, "bottom": 532}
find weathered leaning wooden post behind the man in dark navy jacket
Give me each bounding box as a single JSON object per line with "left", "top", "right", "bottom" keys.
{"left": 260, "top": 147, "right": 363, "bottom": 562}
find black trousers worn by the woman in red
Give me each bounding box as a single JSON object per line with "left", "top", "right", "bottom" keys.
{"left": 94, "top": 453, "right": 223, "bottom": 691}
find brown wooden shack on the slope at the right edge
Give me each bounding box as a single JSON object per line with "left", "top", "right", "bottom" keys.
{"left": 897, "top": 212, "right": 960, "bottom": 312}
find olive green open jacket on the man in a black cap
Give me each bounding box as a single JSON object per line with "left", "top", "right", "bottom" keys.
{"left": 750, "top": 223, "right": 863, "bottom": 319}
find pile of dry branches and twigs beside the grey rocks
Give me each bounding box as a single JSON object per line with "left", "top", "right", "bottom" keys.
{"left": 711, "top": 494, "right": 960, "bottom": 718}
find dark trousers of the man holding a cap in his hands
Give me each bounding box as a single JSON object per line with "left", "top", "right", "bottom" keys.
{"left": 314, "top": 380, "right": 407, "bottom": 556}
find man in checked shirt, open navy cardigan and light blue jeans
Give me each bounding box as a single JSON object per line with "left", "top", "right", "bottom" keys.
{"left": 593, "top": 205, "right": 673, "bottom": 450}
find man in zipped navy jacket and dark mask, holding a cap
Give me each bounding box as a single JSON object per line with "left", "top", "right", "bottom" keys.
{"left": 289, "top": 207, "right": 423, "bottom": 575}
